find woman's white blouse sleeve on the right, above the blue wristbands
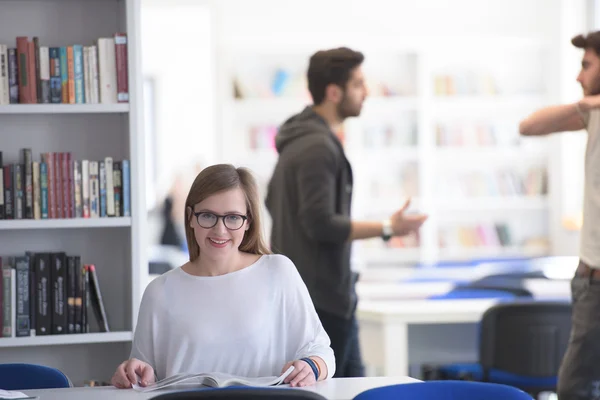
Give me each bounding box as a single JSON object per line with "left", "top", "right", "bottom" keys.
{"left": 277, "top": 255, "right": 335, "bottom": 378}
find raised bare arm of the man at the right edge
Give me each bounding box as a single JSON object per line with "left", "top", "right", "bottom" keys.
{"left": 519, "top": 102, "right": 587, "bottom": 136}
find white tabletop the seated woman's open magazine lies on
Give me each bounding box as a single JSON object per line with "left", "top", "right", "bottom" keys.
{"left": 22, "top": 376, "right": 419, "bottom": 400}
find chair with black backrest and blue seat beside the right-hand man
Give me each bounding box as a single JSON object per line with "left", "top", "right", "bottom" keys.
{"left": 433, "top": 301, "right": 571, "bottom": 396}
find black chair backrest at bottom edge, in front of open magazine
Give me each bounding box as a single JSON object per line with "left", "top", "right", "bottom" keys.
{"left": 152, "top": 386, "right": 325, "bottom": 400}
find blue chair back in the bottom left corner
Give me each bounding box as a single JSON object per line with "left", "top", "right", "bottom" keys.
{"left": 0, "top": 364, "right": 72, "bottom": 390}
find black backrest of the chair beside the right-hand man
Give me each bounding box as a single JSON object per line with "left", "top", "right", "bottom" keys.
{"left": 479, "top": 301, "right": 571, "bottom": 378}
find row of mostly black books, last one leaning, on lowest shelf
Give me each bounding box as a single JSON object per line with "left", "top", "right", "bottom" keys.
{"left": 0, "top": 252, "right": 110, "bottom": 340}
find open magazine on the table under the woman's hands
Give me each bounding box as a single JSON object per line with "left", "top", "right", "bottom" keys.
{"left": 133, "top": 366, "right": 294, "bottom": 392}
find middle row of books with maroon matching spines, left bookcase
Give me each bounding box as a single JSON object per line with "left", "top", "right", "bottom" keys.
{"left": 0, "top": 149, "right": 131, "bottom": 219}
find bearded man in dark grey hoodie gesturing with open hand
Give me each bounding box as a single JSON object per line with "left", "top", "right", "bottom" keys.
{"left": 266, "top": 48, "right": 427, "bottom": 377}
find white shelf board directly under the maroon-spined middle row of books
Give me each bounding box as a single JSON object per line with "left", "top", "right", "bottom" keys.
{"left": 0, "top": 217, "right": 131, "bottom": 230}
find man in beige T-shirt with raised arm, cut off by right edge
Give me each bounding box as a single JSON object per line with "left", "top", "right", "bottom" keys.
{"left": 519, "top": 32, "right": 600, "bottom": 400}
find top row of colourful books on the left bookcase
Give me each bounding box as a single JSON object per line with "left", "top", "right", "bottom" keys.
{"left": 0, "top": 33, "right": 129, "bottom": 105}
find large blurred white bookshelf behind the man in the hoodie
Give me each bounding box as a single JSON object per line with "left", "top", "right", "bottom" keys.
{"left": 221, "top": 37, "right": 556, "bottom": 268}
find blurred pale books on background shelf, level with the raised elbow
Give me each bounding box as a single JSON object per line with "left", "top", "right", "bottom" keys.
{"left": 435, "top": 123, "right": 521, "bottom": 146}
